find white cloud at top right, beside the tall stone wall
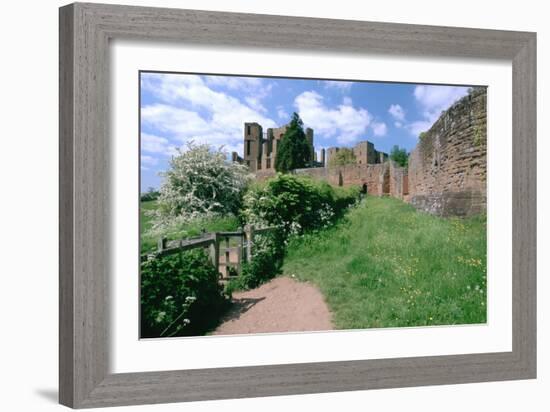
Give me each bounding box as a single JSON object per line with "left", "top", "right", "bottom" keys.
{"left": 414, "top": 85, "right": 468, "bottom": 123}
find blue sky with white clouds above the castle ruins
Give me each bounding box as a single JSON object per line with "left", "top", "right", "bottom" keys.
{"left": 140, "top": 72, "right": 468, "bottom": 191}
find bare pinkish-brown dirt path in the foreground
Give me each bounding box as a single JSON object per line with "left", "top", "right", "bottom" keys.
{"left": 213, "top": 277, "right": 333, "bottom": 335}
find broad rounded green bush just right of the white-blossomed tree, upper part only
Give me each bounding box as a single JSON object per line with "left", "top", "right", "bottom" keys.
{"left": 241, "top": 174, "right": 359, "bottom": 235}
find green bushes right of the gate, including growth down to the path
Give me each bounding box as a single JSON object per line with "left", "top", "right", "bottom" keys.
{"left": 227, "top": 174, "right": 359, "bottom": 291}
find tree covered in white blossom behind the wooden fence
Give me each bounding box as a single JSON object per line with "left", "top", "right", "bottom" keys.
{"left": 152, "top": 142, "right": 250, "bottom": 230}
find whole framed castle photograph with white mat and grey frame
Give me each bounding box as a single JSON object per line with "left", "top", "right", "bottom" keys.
{"left": 59, "top": 3, "right": 536, "bottom": 408}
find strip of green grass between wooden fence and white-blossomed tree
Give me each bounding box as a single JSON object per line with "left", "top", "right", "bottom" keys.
{"left": 140, "top": 200, "right": 239, "bottom": 253}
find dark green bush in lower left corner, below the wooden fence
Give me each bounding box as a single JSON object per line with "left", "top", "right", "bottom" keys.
{"left": 141, "top": 249, "right": 229, "bottom": 338}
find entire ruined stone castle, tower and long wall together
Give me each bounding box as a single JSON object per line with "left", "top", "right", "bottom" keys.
{"left": 233, "top": 87, "right": 487, "bottom": 216}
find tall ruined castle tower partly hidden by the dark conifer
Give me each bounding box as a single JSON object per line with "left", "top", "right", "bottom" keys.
{"left": 240, "top": 123, "right": 314, "bottom": 172}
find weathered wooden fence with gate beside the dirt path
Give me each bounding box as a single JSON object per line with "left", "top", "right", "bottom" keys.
{"left": 141, "top": 226, "right": 276, "bottom": 280}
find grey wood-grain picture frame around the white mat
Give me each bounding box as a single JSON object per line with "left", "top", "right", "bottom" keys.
{"left": 59, "top": 3, "right": 536, "bottom": 408}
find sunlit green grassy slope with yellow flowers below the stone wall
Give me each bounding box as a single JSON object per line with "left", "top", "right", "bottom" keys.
{"left": 283, "top": 197, "right": 487, "bottom": 329}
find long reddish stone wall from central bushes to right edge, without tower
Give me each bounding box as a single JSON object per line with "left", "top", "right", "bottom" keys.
{"left": 295, "top": 87, "right": 487, "bottom": 216}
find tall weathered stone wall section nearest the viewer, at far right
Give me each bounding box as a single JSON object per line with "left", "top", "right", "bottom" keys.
{"left": 408, "top": 88, "right": 487, "bottom": 216}
